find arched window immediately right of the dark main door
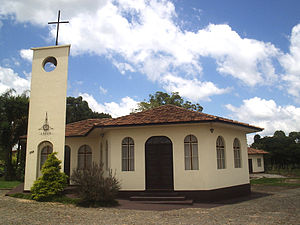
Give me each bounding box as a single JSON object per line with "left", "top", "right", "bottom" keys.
{"left": 184, "top": 135, "right": 199, "bottom": 170}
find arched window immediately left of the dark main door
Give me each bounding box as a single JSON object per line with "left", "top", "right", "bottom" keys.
{"left": 122, "top": 137, "right": 134, "bottom": 171}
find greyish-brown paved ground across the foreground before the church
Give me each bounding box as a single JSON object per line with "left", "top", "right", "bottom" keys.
{"left": 0, "top": 187, "right": 300, "bottom": 224}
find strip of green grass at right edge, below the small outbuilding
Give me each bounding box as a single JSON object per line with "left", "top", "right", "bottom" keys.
{"left": 250, "top": 178, "right": 300, "bottom": 187}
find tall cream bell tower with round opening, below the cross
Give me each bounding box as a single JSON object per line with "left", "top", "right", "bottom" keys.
{"left": 24, "top": 45, "right": 70, "bottom": 191}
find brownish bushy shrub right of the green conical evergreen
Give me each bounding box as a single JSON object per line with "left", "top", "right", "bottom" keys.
{"left": 71, "top": 163, "right": 120, "bottom": 206}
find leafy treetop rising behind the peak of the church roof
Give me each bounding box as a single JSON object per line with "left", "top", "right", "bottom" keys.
{"left": 135, "top": 91, "right": 203, "bottom": 112}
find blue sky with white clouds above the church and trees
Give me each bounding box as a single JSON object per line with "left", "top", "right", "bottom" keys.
{"left": 0, "top": 0, "right": 300, "bottom": 142}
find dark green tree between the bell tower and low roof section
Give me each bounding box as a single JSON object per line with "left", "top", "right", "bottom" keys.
{"left": 66, "top": 96, "right": 111, "bottom": 123}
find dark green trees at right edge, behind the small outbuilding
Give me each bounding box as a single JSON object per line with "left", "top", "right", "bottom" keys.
{"left": 251, "top": 131, "right": 300, "bottom": 169}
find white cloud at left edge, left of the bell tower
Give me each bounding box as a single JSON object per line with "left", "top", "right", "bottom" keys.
{"left": 0, "top": 66, "right": 30, "bottom": 94}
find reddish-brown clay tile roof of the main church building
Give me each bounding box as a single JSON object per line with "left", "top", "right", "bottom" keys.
{"left": 66, "top": 105, "right": 263, "bottom": 137}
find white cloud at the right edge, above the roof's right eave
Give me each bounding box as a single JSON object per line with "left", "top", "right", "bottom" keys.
{"left": 226, "top": 97, "right": 300, "bottom": 141}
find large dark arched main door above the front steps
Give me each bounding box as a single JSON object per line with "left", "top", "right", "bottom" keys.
{"left": 145, "top": 136, "right": 174, "bottom": 190}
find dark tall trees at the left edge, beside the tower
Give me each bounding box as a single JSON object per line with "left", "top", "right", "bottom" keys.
{"left": 0, "top": 90, "right": 29, "bottom": 180}
